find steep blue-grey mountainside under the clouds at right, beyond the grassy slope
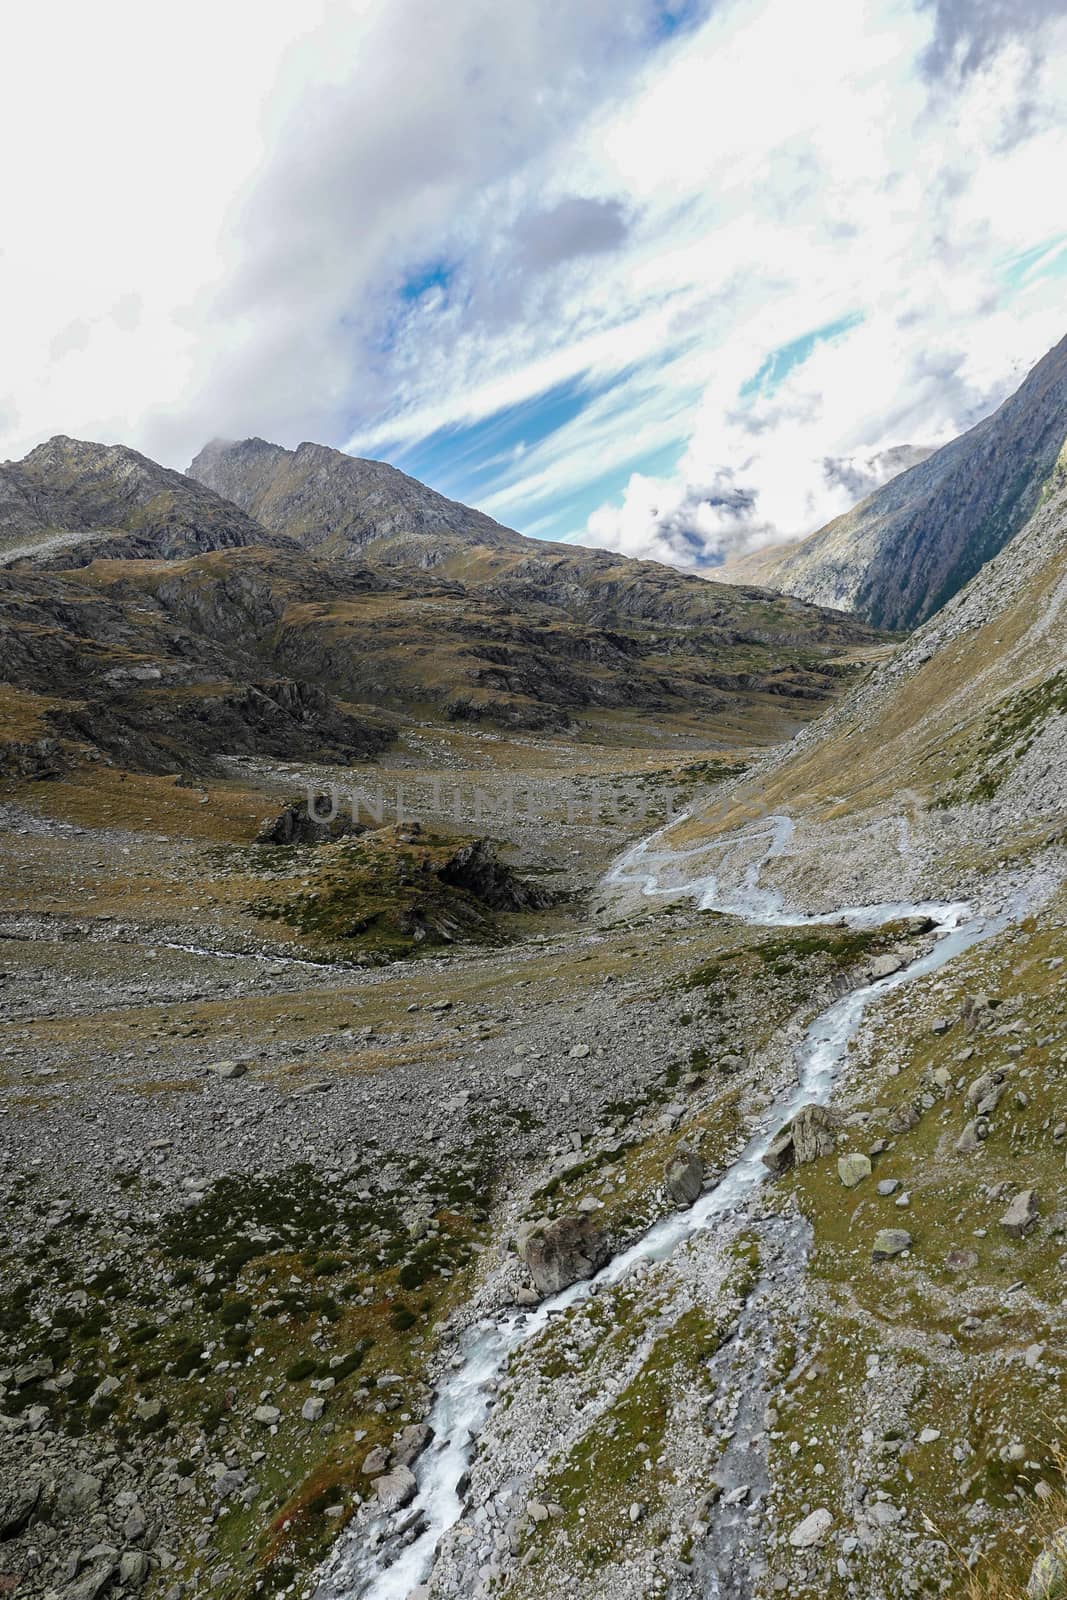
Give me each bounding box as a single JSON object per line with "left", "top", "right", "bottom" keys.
{"left": 718, "top": 338, "right": 1067, "bottom": 629}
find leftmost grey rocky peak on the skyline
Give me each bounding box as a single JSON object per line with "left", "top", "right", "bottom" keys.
{"left": 0, "top": 434, "right": 283, "bottom": 565}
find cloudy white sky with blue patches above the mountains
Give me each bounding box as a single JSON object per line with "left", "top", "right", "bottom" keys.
{"left": 0, "top": 0, "right": 1067, "bottom": 570}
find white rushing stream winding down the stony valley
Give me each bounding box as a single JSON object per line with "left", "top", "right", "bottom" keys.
{"left": 318, "top": 816, "right": 1001, "bottom": 1600}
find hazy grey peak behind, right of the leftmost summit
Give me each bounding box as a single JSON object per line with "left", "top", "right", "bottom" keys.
{"left": 189, "top": 438, "right": 528, "bottom": 566}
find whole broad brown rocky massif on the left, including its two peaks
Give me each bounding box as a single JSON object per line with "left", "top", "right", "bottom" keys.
{"left": 0, "top": 437, "right": 878, "bottom": 773}
